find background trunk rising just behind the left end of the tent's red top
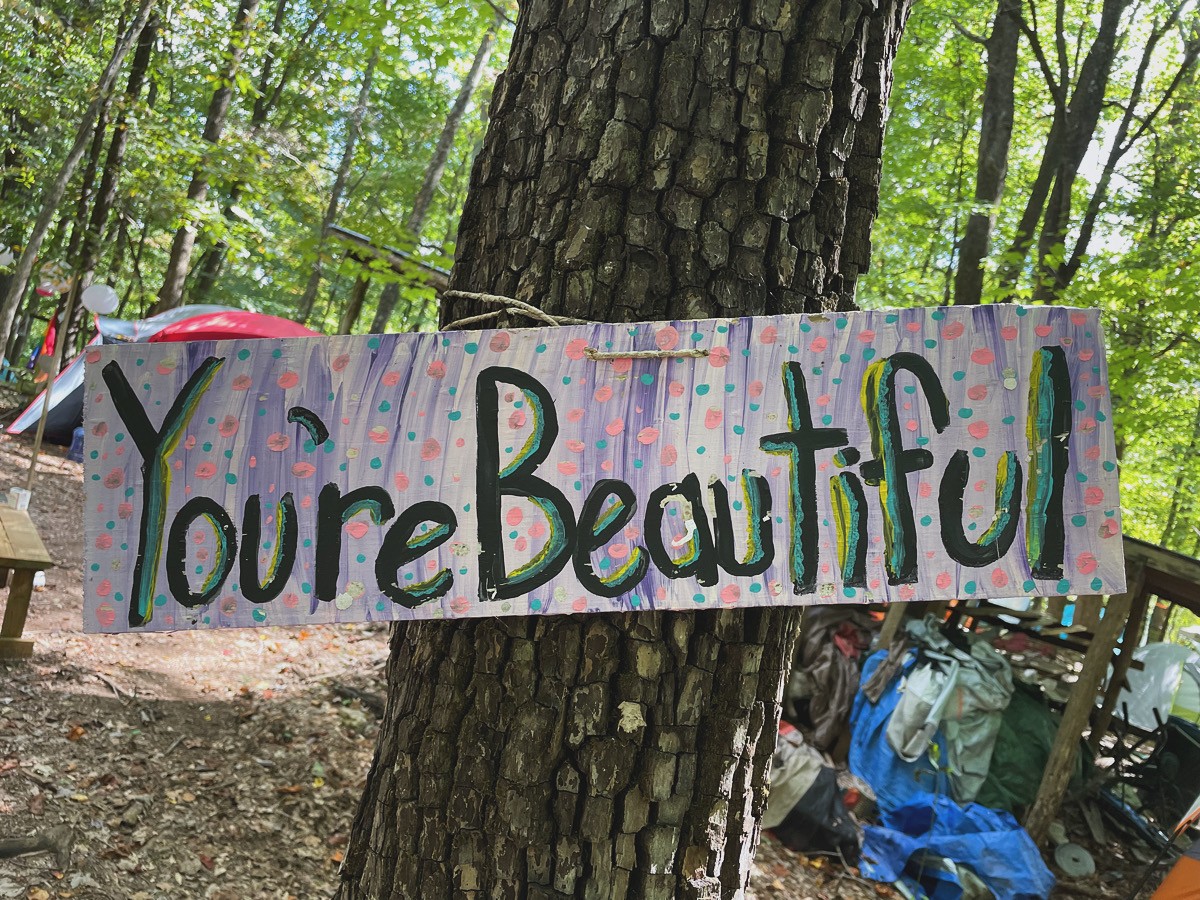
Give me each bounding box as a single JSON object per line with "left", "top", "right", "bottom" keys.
{"left": 151, "top": 0, "right": 258, "bottom": 314}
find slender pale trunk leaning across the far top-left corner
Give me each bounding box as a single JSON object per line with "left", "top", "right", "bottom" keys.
{"left": 0, "top": 0, "right": 155, "bottom": 362}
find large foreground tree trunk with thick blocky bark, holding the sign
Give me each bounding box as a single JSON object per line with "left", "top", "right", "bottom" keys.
{"left": 338, "top": 0, "right": 908, "bottom": 900}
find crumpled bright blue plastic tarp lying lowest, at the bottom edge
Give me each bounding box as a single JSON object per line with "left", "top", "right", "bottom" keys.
{"left": 859, "top": 792, "right": 1055, "bottom": 900}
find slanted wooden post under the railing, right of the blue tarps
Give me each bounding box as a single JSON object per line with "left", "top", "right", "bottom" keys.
{"left": 1025, "top": 562, "right": 1145, "bottom": 844}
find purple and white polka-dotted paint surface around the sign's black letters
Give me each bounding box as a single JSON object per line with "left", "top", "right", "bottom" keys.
{"left": 84, "top": 305, "right": 1124, "bottom": 631}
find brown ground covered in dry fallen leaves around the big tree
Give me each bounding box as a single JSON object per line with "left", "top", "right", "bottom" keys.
{"left": 0, "top": 437, "right": 1171, "bottom": 900}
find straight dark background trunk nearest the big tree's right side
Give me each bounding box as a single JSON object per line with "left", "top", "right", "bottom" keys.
{"left": 954, "top": 0, "right": 1020, "bottom": 305}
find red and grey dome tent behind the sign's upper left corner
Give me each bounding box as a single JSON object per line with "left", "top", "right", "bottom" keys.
{"left": 7, "top": 304, "right": 318, "bottom": 446}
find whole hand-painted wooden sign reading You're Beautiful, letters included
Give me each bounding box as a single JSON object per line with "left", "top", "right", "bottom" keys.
{"left": 85, "top": 305, "right": 1124, "bottom": 631}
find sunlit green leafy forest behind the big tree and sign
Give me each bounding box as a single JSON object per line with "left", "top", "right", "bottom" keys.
{"left": 0, "top": 0, "right": 1200, "bottom": 628}
